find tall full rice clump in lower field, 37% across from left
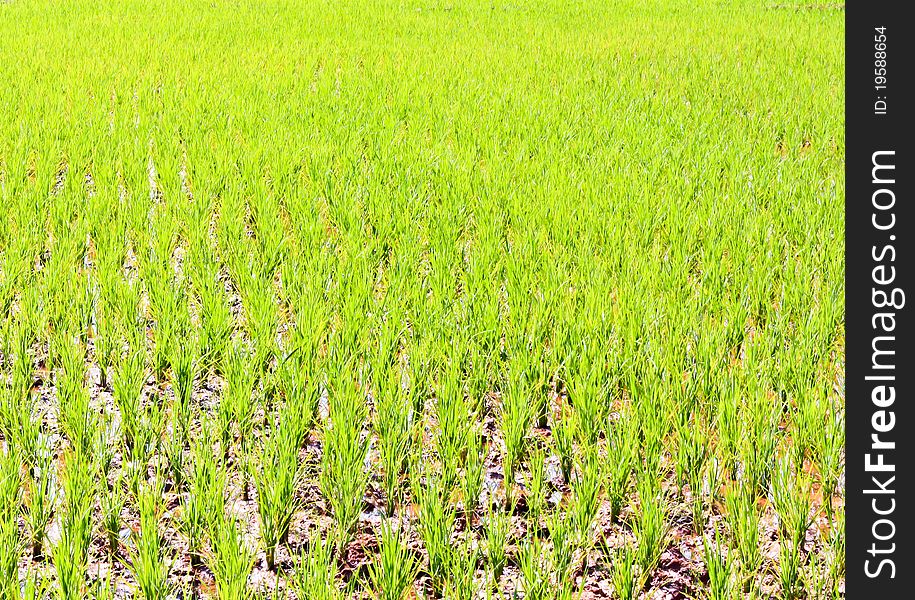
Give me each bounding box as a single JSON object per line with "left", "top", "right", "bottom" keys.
{"left": 319, "top": 380, "right": 369, "bottom": 550}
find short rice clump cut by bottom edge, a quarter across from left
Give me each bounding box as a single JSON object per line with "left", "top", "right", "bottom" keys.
{"left": 205, "top": 512, "right": 254, "bottom": 600}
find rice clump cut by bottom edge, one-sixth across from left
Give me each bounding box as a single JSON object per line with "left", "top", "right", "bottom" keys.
{"left": 129, "top": 484, "right": 171, "bottom": 600}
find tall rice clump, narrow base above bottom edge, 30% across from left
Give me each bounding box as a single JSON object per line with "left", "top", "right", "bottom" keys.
{"left": 254, "top": 415, "right": 302, "bottom": 571}
